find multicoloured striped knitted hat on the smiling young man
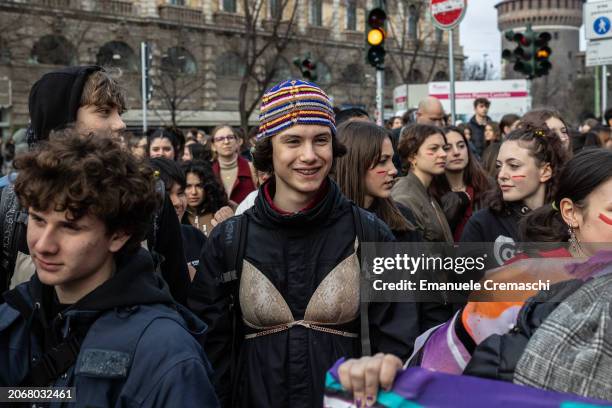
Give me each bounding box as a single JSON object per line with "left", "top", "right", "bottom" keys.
{"left": 257, "top": 79, "right": 336, "bottom": 141}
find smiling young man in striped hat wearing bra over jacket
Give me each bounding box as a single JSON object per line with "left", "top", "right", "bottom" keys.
{"left": 189, "top": 80, "right": 419, "bottom": 408}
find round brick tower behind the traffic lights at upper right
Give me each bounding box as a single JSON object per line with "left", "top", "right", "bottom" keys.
{"left": 495, "top": 0, "right": 584, "bottom": 118}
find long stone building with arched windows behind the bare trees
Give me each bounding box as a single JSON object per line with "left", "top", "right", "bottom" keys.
{"left": 0, "top": 0, "right": 463, "bottom": 137}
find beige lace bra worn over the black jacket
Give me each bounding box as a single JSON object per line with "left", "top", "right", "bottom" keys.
{"left": 239, "top": 239, "right": 360, "bottom": 339}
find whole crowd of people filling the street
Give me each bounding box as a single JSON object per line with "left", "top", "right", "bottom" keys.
{"left": 0, "top": 66, "right": 612, "bottom": 407}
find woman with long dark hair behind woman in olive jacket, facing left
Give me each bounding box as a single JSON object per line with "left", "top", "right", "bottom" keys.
{"left": 429, "top": 126, "right": 491, "bottom": 241}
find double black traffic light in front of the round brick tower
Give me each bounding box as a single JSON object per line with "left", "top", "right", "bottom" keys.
{"left": 502, "top": 24, "right": 552, "bottom": 79}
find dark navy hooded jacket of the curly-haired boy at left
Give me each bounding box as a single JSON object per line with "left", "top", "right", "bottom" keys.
{"left": 0, "top": 249, "right": 217, "bottom": 407}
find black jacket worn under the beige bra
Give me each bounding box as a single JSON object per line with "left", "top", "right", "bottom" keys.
{"left": 189, "top": 179, "right": 420, "bottom": 407}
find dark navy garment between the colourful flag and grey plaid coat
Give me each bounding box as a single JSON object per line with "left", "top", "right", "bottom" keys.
{"left": 463, "top": 279, "right": 584, "bottom": 382}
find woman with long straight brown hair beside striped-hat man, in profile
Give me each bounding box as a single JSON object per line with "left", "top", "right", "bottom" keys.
{"left": 334, "top": 121, "right": 421, "bottom": 242}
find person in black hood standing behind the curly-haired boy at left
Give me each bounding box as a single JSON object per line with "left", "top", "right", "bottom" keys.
{"left": 0, "top": 65, "right": 190, "bottom": 303}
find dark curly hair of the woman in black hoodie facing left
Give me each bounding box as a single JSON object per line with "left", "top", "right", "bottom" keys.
{"left": 485, "top": 123, "right": 567, "bottom": 213}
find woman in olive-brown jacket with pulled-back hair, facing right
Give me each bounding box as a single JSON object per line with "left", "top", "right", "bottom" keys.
{"left": 391, "top": 125, "right": 453, "bottom": 243}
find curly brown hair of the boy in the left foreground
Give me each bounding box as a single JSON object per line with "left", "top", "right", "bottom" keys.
{"left": 15, "top": 129, "right": 159, "bottom": 253}
